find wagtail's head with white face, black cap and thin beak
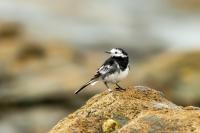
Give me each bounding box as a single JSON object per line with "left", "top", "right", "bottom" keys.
{"left": 106, "top": 48, "right": 128, "bottom": 57}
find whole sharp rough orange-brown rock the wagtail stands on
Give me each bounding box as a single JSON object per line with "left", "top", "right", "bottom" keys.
{"left": 50, "top": 86, "right": 200, "bottom": 133}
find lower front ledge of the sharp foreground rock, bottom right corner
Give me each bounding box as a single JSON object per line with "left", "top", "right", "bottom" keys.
{"left": 118, "top": 109, "right": 200, "bottom": 133}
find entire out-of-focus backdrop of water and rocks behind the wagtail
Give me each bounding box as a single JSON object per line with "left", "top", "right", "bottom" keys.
{"left": 0, "top": 0, "right": 200, "bottom": 133}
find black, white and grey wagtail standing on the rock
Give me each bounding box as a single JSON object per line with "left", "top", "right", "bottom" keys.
{"left": 75, "top": 48, "right": 129, "bottom": 94}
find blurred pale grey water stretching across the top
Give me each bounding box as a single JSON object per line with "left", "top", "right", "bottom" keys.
{"left": 0, "top": 0, "right": 200, "bottom": 50}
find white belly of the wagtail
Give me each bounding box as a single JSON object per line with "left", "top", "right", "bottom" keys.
{"left": 104, "top": 68, "right": 129, "bottom": 83}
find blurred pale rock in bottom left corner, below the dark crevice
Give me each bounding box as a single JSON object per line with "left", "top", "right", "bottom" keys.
{"left": 0, "top": 105, "right": 68, "bottom": 133}
